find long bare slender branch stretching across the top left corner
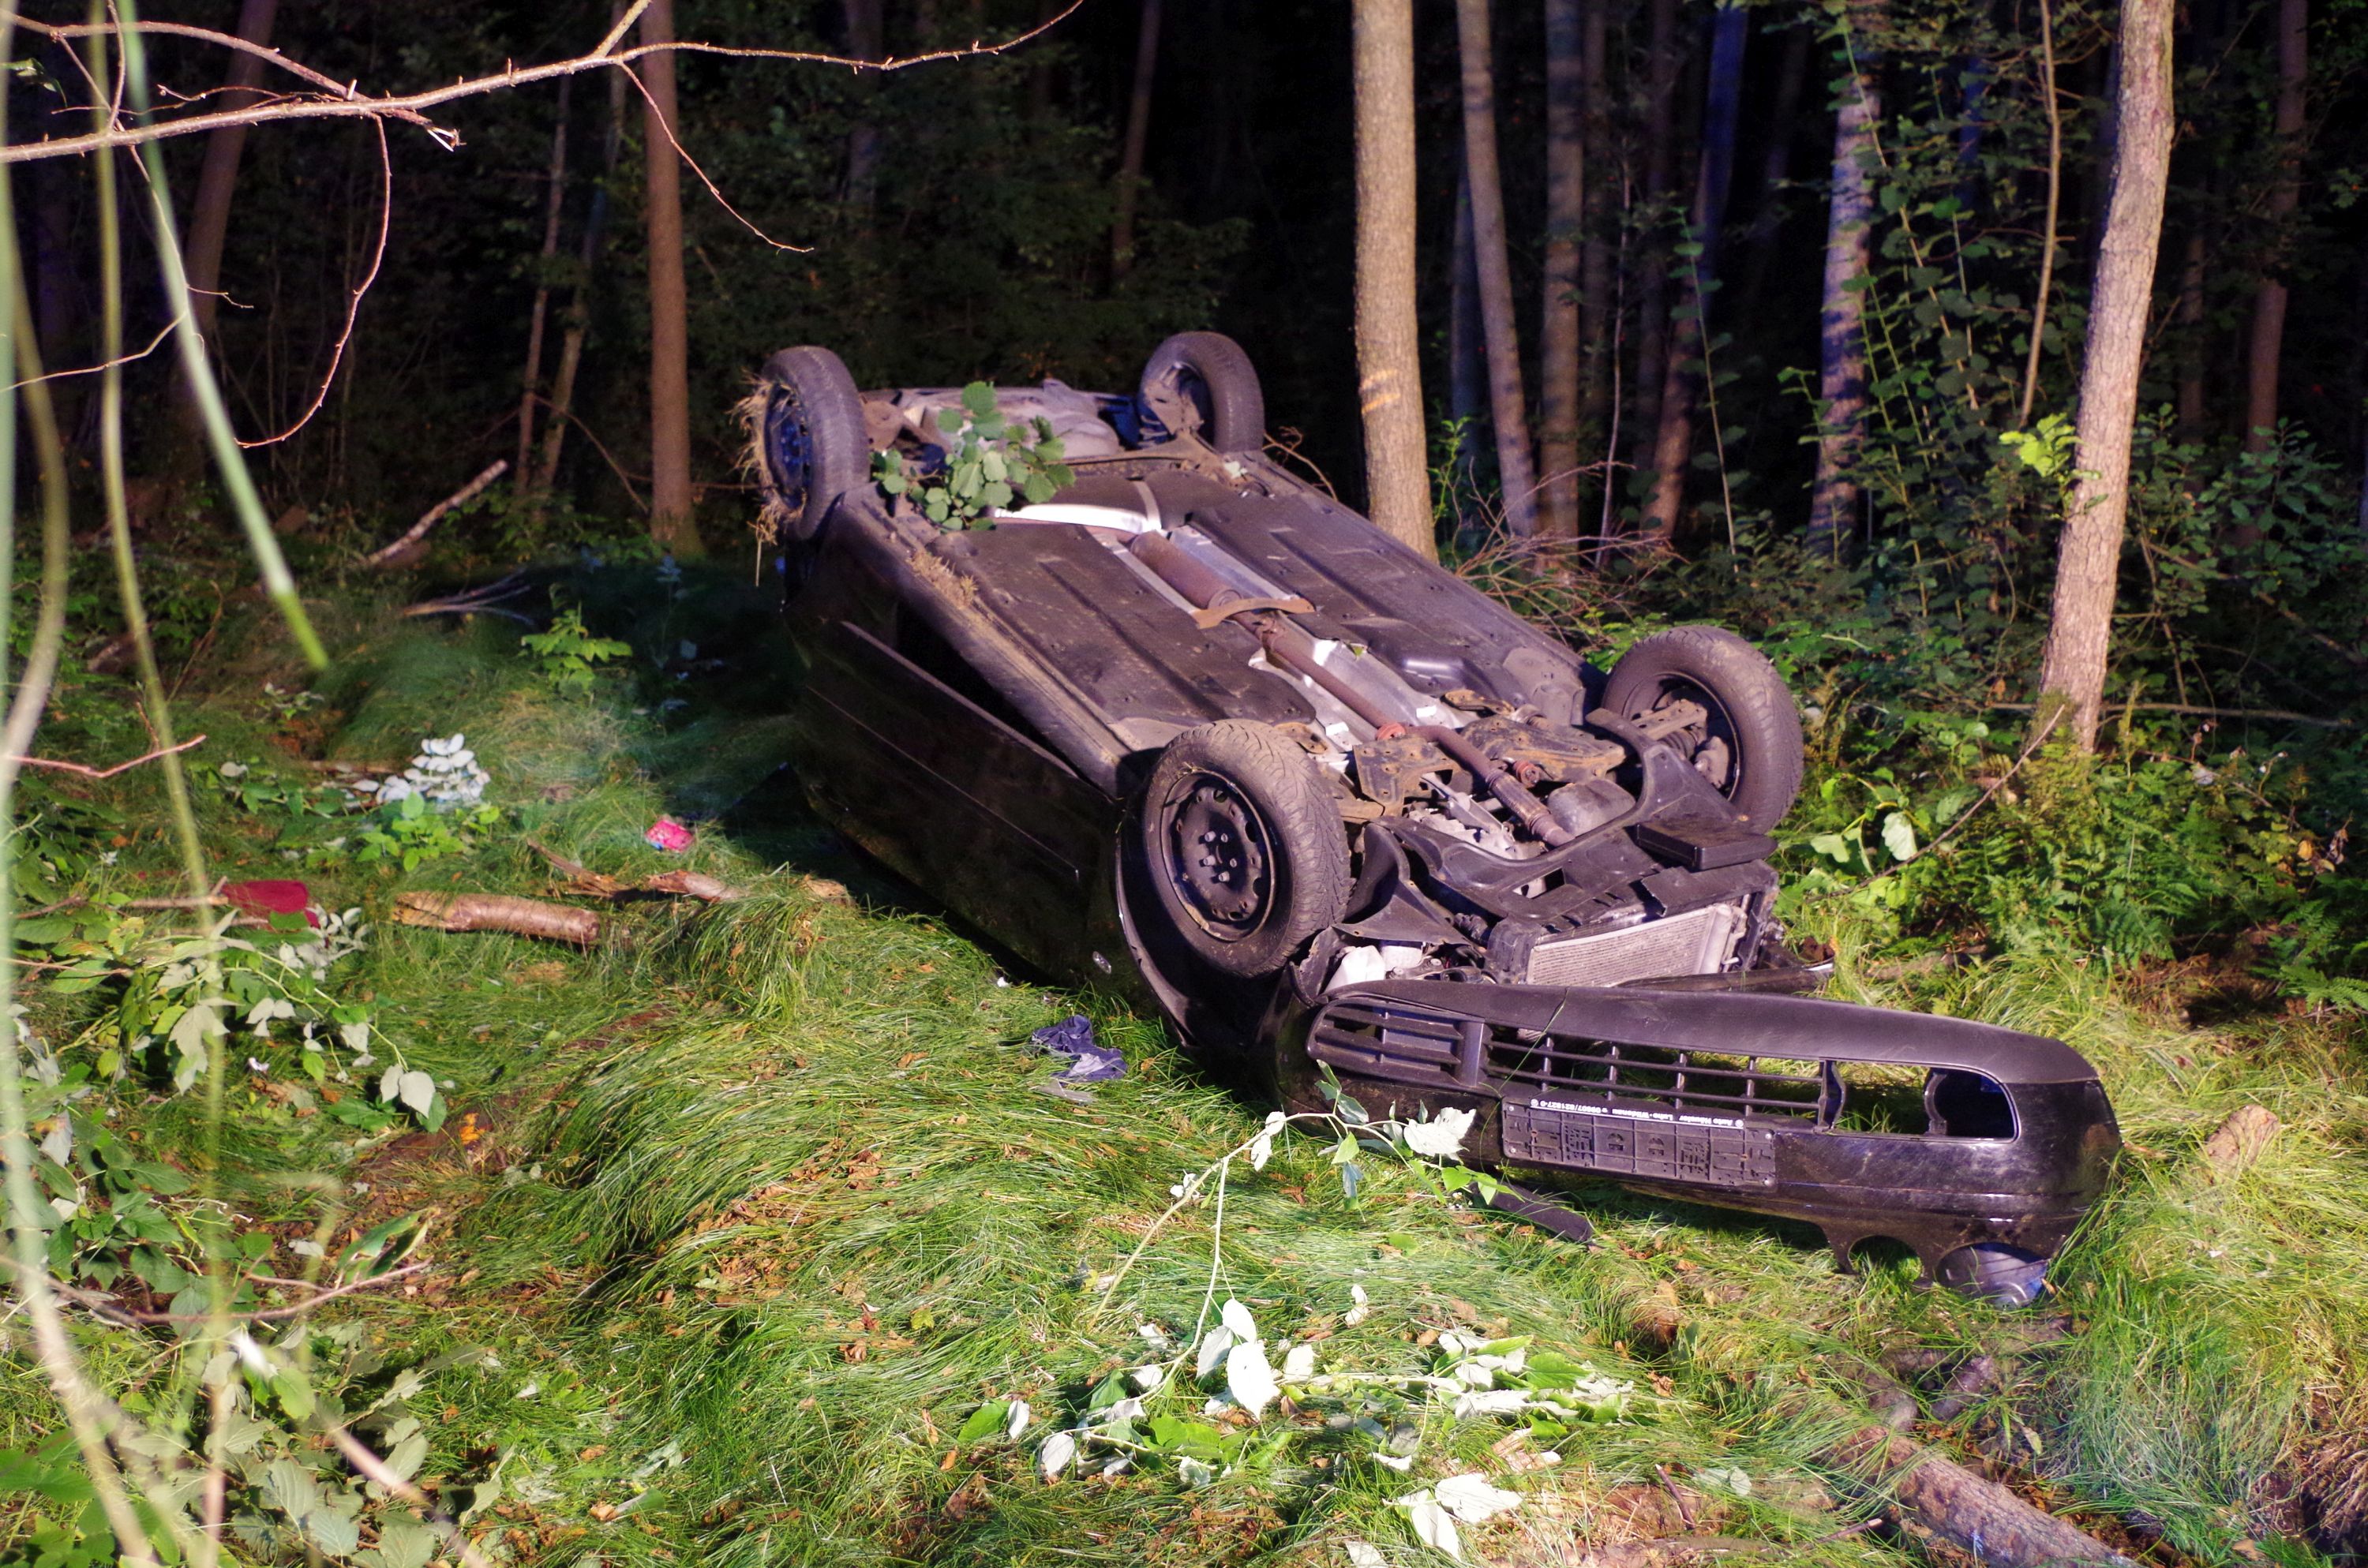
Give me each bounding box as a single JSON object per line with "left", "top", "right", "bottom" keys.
{"left": 0, "top": 0, "right": 1085, "bottom": 163}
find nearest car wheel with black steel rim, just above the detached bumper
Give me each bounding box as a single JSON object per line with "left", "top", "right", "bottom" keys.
{"left": 1139, "top": 717, "right": 1350, "bottom": 979}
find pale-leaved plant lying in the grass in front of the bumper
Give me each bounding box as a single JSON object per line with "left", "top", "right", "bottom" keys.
{"left": 959, "top": 1073, "right": 1636, "bottom": 1554}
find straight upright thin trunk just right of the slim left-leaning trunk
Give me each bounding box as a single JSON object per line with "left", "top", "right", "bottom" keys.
{"left": 1537, "top": 0, "right": 1587, "bottom": 540}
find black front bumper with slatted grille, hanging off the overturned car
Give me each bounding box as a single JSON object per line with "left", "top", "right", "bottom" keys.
{"left": 1305, "top": 981, "right": 2119, "bottom": 1274}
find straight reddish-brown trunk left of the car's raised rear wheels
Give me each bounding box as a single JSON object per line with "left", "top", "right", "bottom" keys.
{"left": 642, "top": 0, "right": 699, "bottom": 554}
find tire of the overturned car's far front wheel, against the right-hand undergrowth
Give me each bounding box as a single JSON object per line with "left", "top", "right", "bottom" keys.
{"left": 1603, "top": 625, "right": 1802, "bottom": 834}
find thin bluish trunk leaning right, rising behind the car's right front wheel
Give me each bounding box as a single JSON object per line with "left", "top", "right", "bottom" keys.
{"left": 1639, "top": 5, "right": 1752, "bottom": 547}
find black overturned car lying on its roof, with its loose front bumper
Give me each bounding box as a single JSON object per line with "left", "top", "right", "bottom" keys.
{"left": 748, "top": 334, "right": 2119, "bottom": 1303}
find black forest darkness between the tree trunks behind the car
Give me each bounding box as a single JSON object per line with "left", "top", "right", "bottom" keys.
{"left": 12, "top": 0, "right": 2368, "bottom": 542}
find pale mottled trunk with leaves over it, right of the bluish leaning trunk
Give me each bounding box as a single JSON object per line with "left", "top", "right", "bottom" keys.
{"left": 1809, "top": 33, "right": 1875, "bottom": 556}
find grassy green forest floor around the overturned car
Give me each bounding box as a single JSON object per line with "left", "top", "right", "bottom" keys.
{"left": 0, "top": 566, "right": 2368, "bottom": 1568}
